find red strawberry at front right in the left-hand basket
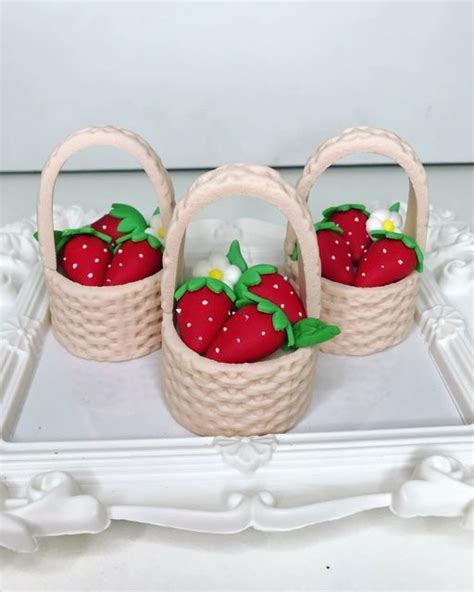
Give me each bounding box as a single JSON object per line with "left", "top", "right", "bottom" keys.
{"left": 104, "top": 231, "right": 162, "bottom": 286}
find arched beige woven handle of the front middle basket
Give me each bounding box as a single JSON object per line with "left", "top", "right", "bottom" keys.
{"left": 161, "top": 164, "right": 321, "bottom": 317}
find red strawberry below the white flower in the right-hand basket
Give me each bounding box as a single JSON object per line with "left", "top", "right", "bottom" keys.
{"left": 354, "top": 230, "right": 423, "bottom": 288}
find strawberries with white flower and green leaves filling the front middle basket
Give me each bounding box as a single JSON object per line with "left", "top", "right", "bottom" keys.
{"left": 175, "top": 241, "right": 340, "bottom": 363}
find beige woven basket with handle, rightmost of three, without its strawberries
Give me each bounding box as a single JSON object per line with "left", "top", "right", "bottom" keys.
{"left": 285, "top": 127, "right": 429, "bottom": 356}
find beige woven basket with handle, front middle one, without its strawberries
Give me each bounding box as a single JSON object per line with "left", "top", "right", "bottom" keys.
{"left": 162, "top": 165, "right": 320, "bottom": 436}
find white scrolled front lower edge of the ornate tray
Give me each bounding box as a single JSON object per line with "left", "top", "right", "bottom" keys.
{"left": 0, "top": 454, "right": 474, "bottom": 552}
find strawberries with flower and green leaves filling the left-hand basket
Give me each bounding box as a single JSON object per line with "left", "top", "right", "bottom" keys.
{"left": 35, "top": 203, "right": 164, "bottom": 286}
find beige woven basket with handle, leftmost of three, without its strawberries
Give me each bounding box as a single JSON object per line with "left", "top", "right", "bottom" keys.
{"left": 37, "top": 127, "right": 174, "bottom": 362}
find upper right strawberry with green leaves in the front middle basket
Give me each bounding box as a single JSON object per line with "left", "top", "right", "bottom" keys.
{"left": 227, "top": 241, "right": 306, "bottom": 323}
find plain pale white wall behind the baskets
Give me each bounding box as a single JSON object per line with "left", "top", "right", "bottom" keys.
{"left": 0, "top": 0, "right": 474, "bottom": 171}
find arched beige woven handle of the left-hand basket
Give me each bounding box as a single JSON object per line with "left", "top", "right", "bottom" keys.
{"left": 37, "top": 126, "right": 174, "bottom": 271}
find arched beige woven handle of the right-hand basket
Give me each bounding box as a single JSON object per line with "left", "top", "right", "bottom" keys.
{"left": 285, "top": 127, "right": 429, "bottom": 255}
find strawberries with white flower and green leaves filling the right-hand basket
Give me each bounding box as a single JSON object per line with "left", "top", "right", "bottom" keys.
{"left": 291, "top": 203, "right": 423, "bottom": 288}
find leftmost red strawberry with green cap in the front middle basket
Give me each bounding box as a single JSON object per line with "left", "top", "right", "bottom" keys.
{"left": 175, "top": 277, "right": 235, "bottom": 354}
